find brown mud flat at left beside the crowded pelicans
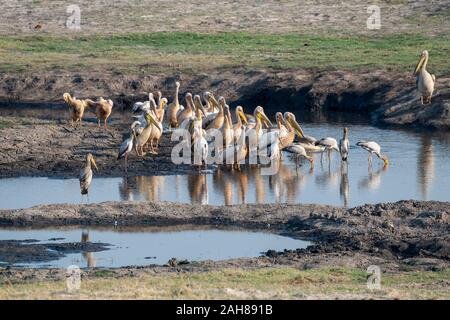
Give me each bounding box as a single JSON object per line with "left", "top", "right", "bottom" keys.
{"left": 0, "top": 117, "right": 197, "bottom": 178}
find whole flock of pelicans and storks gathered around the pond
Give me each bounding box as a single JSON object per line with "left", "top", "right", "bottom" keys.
{"left": 59, "top": 50, "right": 436, "bottom": 195}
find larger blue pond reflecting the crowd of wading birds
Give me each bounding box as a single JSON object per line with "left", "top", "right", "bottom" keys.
{"left": 0, "top": 118, "right": 450, "bottom": 208}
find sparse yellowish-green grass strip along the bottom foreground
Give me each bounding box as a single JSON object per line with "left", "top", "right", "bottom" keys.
{"left": 0, "top": 268, "right": 450, "bottom": 299}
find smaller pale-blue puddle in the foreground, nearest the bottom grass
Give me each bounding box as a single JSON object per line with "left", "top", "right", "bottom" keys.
{"left": 0, "top": 228, "right": 309, "bottom": 268}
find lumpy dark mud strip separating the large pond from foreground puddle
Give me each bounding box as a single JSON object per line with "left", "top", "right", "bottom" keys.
{"left": 0, "top": 201, "right": 450, "bottom": 268}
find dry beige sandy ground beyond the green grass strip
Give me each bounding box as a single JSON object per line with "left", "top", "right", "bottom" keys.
{"left": 0, "top": 0, "right": 450, "bottom": 35}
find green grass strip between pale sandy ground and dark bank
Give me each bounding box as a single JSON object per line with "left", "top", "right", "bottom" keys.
{"left": 0, "top": 32, "right": 450, "bottom": 74}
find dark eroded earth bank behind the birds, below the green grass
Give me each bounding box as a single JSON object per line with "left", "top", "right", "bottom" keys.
{"left": 0, "top": 69, "right": 450, "bottom": 130}
